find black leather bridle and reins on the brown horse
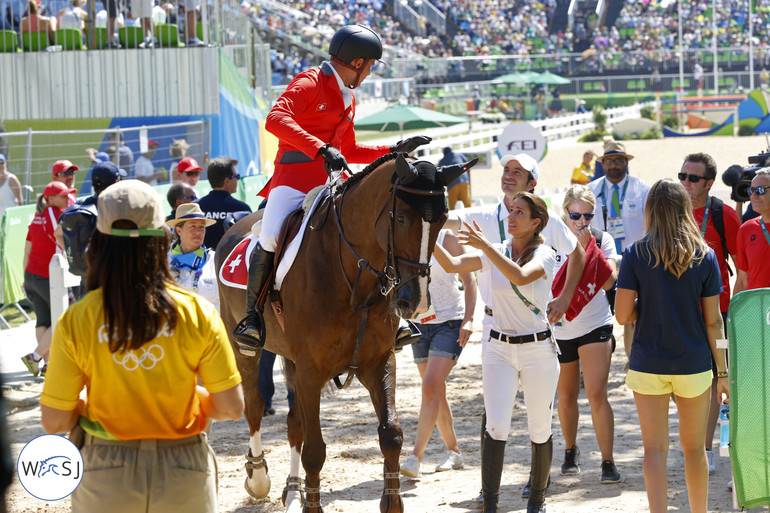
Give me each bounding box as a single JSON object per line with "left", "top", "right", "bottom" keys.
{"left": 331, "top": 174, "right": 444, "bottom": 389}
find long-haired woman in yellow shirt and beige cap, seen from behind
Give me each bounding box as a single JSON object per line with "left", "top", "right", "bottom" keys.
{"left": 40, "top": 180, "right": 244, "bottom": 513}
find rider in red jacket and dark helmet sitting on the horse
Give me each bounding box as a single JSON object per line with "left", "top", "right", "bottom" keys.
{"left": 233, "top": 25, "right": 430, "bottom": 356}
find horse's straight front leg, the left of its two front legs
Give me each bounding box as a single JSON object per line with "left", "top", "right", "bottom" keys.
{"left": 295, "top": 369, "right": 326, "bottom": 513}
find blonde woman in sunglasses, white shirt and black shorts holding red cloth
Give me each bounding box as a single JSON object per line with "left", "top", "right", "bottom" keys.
{"left": 553, "top": 185, "right": 620, "bottom": 484}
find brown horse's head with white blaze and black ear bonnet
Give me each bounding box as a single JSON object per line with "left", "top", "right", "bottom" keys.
{"left": 377, "top": 155, "right": 478, "bottom": 319}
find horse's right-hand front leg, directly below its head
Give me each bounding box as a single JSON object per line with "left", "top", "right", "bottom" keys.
{"left": 358, "top": 351, "right": 404, "bottom": 513}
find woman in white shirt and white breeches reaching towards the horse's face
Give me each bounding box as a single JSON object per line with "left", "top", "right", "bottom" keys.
{"left": 434, "top": 192, "right": 559, "bottom": 513}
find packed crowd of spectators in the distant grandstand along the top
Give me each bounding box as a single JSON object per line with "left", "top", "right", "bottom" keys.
{"left": 260, "top": 0, "right": 770, "bottom": 80}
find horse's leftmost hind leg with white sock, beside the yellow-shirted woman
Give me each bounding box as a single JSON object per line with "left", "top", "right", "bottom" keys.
{"left": 236, "top": 349, "right": 270, "bottom": 499}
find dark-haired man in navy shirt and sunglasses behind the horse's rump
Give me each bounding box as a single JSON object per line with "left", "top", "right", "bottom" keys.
{"left": 196, "top": 157, "right": 251, "bottom": 249}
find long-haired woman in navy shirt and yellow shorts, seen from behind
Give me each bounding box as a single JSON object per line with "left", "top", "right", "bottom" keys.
{"left": 615, "top": 178, "right": 728, "bottom": 513}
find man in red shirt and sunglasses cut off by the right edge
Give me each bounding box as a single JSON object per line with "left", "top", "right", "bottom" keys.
{"left": 734, "top": 167, "right": 770, "bottom": 294}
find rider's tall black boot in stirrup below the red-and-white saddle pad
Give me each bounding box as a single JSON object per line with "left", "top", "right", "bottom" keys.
{"left": 233, "top": 243, "right": 275, "bottom": 356}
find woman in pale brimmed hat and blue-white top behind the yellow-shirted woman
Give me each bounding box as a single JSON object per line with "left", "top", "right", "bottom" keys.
{"left": 168, "top": 203, "right": 219, "bottom": 312}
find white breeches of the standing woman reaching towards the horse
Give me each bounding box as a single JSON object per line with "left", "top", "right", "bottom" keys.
{"left": 481, "top": 338, "right": 559, "bottom": 444}
